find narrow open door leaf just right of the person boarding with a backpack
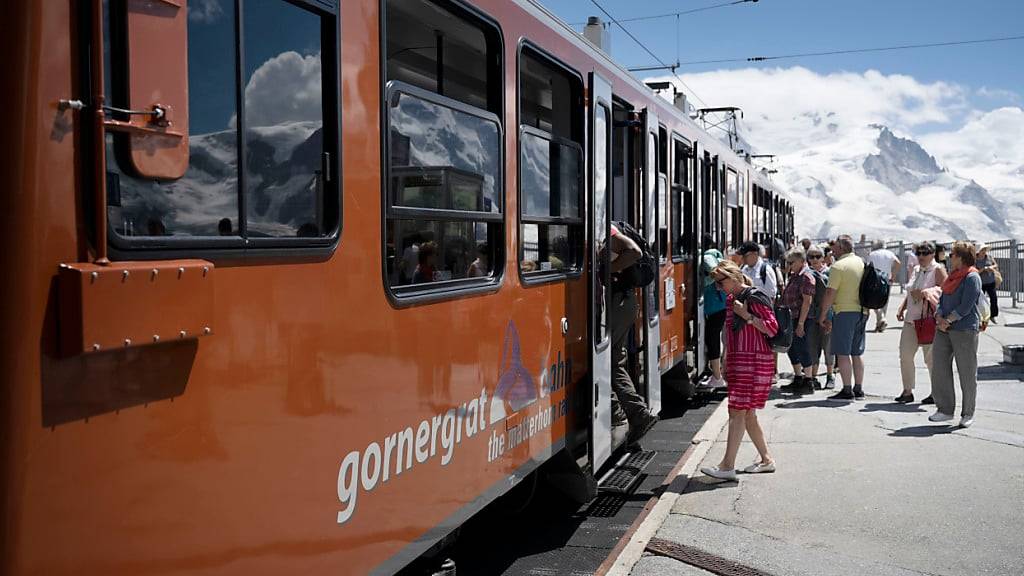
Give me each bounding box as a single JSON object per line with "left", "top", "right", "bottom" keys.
{"left": 640, "top": 108, "right": 662, "bottom": 414}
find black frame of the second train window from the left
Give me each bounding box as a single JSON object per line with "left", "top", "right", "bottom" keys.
{"left": 378, "top": 0, "right": 508, "bottom": 308}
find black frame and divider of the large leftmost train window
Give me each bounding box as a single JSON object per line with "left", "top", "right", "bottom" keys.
{"left": 104, "top": 0, "right": 344, "bottom": 258}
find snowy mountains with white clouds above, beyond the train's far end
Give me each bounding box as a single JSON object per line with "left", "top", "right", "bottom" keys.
{"left": 650, "top": 67, "right": 1024, "bottom": 241}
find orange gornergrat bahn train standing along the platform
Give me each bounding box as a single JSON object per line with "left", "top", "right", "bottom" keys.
{"left": 0, "top": 0, "right": 794, "bottom": 575}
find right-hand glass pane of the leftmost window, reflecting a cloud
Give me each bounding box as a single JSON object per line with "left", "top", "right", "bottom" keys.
{"left": 243, "top": 2, "right": 325, "bottom": 237}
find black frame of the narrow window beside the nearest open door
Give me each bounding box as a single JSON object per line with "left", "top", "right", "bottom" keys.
{"left": 515, "top": 37, "right": 588, "bottom": 287}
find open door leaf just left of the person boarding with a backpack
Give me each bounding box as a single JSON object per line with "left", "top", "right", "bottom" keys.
{"left": 587, "top": 73, "right": 611, "bottom": 471}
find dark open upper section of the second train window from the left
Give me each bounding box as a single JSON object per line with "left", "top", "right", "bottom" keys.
{"left": 385, "top": 0, "right": 501, "bottom": 113}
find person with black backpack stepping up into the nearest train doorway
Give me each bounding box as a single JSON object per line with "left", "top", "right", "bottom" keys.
{"left": 608, "top": 225, "right": 657, "bottom": 445}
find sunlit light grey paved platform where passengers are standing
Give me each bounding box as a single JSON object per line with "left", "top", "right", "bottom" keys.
{"left": 623, "top": 295, "right": 1024, "bottom": 576}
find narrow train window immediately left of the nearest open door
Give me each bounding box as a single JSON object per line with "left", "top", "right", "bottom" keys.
{"left": 519, "top": 44, "right": 584, "bottom": 278}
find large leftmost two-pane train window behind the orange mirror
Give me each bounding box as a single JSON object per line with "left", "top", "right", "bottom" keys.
{"left": 104, "top": 0, "right": 341, "bottom": 250}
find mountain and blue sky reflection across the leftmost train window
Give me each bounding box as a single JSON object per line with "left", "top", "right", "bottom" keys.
{"left": 100, "top": 0, "right": 337, "bottom": 238}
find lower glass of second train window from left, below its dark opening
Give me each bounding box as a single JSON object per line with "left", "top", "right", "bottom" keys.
{"left": 385, "top": 83, "right": 503, "bottom": 288}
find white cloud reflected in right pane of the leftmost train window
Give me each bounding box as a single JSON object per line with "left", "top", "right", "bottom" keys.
{"left": 239, "top": 51, "right": 324, "bottom": 127}
